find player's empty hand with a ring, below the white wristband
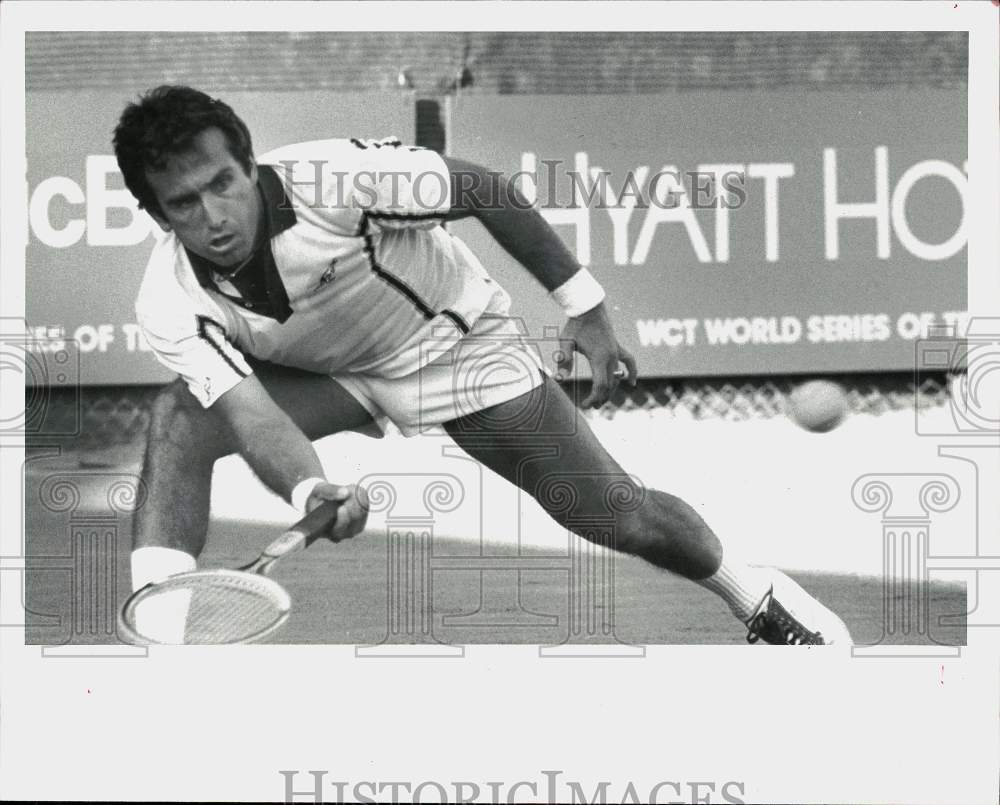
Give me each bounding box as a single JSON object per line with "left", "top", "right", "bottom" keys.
{"left": 556, "top": 304, "right": 639, "bottom": 408}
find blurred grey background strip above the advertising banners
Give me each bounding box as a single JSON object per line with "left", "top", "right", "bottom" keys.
{"left": 26, "top": 31, "right": 968, "bottom": 95}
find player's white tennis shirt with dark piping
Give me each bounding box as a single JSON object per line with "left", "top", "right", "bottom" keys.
{"left": 135, "top": 139, "right": 503, "bottom": 408}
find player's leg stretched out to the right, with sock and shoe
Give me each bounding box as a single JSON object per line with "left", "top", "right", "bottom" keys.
{"left": 445, "top": 378, "right": 846, "bottom": 642}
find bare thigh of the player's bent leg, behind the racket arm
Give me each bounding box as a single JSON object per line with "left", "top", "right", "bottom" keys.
{"left": 252, "top": 361, "right": 380, "bottom": 440}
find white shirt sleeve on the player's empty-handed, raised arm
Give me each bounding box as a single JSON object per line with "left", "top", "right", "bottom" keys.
{"left": 350, "top": 138, "right": 451, "bottom": 229}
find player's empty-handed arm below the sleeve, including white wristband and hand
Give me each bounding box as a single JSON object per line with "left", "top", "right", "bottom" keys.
{"left": 444, "top": 157, "right": 637, "bottom": 408}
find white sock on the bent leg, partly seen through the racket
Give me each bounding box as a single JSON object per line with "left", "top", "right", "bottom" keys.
{"left": 132, "top": 545, "right": 197, "bottom": 643}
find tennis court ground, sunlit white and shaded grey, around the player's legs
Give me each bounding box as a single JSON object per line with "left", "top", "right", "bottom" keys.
{"left": 25, "top": 382, "right": 974, "bottom": 646}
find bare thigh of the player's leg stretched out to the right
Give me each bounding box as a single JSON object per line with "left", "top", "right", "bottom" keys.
{"left": 445, "top": 377, "right": 644, "bottom": 519}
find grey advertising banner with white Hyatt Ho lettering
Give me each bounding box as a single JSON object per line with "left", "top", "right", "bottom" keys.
{"left": 450, "top": 88, "right": 967, "bottom": 376}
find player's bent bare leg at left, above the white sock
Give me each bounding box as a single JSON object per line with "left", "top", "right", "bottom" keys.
{"left": 133, "top": 364, "right": 372, "bottom": 564}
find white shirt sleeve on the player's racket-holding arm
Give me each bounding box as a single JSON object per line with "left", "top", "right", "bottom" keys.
{"left": 135, "top": 247, "right": 252, "bottom": 408}
